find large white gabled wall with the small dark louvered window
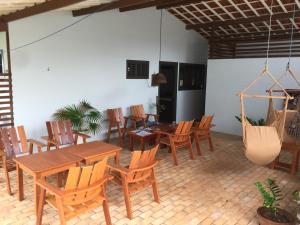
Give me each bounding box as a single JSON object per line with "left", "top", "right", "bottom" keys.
{"left": 9, "top": 9, "right": 206, "bottom": 137}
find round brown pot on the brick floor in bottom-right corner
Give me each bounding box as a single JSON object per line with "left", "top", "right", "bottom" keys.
{"left": 257, "top": 207, "right": 294, "bottom": 225}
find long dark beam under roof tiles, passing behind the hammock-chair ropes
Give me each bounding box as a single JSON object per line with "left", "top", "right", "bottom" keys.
{"left": 186, "top": 11, "right": 300, "bottom": 30}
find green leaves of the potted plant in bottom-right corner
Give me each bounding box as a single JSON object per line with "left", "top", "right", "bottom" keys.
{"left": 255, "top": 178, "right": 282, "bottom": 215}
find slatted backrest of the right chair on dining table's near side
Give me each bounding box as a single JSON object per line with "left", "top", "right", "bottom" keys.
{"left": 128, "top": 145, "right": 158, "bottom": 183}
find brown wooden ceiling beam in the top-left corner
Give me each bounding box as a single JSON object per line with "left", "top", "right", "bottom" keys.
{"left": 0, "top": 0, "right": 84, "bottom": 22}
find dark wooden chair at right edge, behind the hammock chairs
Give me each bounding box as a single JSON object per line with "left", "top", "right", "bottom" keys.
{"left": 271, "top": 142, "right": 300, "bottom": 175}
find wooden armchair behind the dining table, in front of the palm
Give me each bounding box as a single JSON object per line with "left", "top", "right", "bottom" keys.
{"left": 42, "top": 120, "right": 90, "bottom": 151}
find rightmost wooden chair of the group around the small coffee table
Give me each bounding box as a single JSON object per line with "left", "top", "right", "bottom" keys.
{"left": 192, "top": 115, "right": 214, "bottom": 155}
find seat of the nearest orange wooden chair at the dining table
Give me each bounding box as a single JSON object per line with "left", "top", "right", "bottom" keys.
{"left": 46, "top": 194, "right": 104, "bottom": 220}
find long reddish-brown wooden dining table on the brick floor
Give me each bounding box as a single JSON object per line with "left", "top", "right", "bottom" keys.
{"left": 14, "top": 141, "right": 121, "bottom": 212}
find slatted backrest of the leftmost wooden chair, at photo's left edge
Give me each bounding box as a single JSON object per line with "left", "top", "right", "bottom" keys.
{"left": 0, "top": 126, "right": 28, "bottom": 159}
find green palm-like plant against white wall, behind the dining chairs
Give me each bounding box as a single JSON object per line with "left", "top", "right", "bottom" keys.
{"left": 53, "top": 100, "right": 103, "bottom": 135}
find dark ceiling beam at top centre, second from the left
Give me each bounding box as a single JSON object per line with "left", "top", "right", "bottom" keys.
{"left": 72, "top": 0, "right": 155, "bottom": 16}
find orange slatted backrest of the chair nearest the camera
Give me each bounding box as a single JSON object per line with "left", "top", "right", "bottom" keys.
{"left": 63, "top": 158, "right": 107, "bottom": 206}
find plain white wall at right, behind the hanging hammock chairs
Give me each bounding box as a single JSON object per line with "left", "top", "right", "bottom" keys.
{"left": 206, "top": 58, "right": 300, "bottom": 135}
